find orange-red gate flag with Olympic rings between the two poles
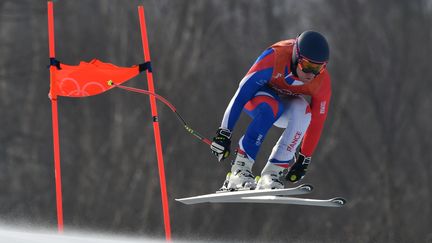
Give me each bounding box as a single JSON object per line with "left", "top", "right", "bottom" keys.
{"left": 49, "top": 59, "right": 140, "bottom": 99}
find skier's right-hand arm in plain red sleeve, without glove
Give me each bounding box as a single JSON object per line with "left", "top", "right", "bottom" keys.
{"left": 301, "top": 72, "right": 331, "bottom": 157}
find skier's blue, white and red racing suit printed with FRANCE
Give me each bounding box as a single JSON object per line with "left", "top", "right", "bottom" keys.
{"left": 221, "top": 39, "right": 331, "bottom": 167}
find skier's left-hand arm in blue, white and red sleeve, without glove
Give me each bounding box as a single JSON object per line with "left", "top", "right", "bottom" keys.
{"left": 221, "top": 49, "right": 274, "bottom": 131}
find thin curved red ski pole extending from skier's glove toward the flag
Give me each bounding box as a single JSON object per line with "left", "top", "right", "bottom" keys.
{"left": 108, "top": 80, "right": 211, "bottom": 145}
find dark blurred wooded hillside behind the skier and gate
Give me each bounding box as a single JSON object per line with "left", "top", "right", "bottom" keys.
{"left": 0, "top": 0, "right": 432, "bottom": 242}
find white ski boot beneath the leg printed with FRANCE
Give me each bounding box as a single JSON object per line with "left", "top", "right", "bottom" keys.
{"left": 256, "top": 162, "right": 288, "bottom": 190}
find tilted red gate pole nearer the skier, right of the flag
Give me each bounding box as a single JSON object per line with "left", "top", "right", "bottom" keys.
{"left": 138, "top": 6, "right": 171, "bottom": 241}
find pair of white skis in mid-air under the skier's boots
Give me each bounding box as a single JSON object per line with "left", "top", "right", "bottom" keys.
{"left": 176, "top": 184, "right": 346, "bottom": 207}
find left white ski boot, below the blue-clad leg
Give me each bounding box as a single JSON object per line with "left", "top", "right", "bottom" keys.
{"left": 220, "top": 151, "right": 256, "bottom": 191}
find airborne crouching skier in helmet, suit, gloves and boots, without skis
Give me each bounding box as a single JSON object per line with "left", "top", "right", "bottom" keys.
{"left": 210, "top": 31, "right": 331, "bottom": 190}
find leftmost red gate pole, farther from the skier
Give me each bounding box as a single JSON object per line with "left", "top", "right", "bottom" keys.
{"left": 48, "top": 1, "right": 63, "bottom": 233}
